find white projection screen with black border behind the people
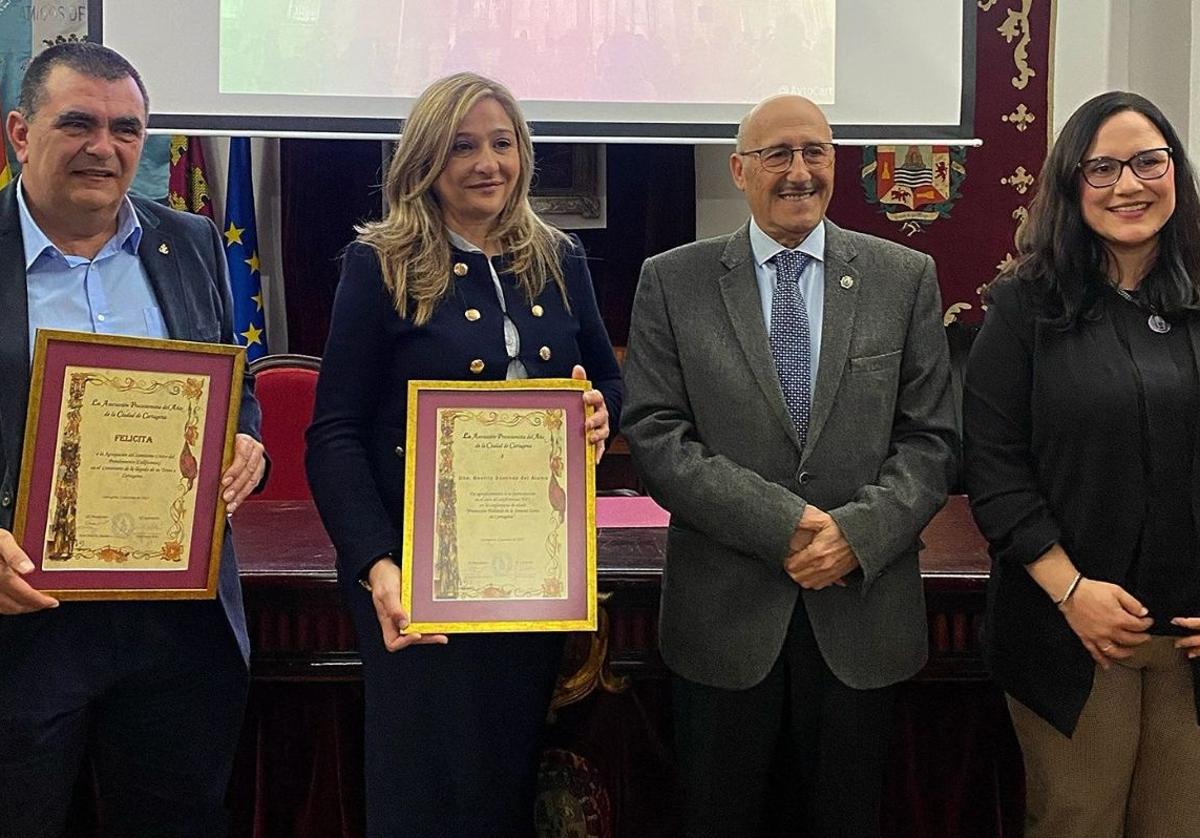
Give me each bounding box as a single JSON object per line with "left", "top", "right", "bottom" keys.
{"left": 89, "top": 0, "right": 976, "bottom": 143}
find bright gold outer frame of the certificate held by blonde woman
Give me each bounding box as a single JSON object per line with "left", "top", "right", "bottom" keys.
{"left": 400, "top": 378, "right": 598, "bottom": 634}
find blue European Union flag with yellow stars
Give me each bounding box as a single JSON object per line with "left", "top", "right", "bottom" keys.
{"left": 224, "top": 137, "right": 266, "bottom": 360}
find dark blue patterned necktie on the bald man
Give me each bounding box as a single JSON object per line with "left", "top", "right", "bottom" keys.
{"left": 770, "top": 250, "right": 812, "bottom": 448}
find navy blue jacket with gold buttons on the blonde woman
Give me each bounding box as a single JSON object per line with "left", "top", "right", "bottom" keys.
{"left": 306, "top": 240, "right": 623, "bottom": 582}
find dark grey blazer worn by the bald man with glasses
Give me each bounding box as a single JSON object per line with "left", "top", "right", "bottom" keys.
{"left": 623, "top": 221, "right": 959, "bottom": 689}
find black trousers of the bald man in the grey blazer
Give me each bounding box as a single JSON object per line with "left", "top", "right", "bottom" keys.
{"left": 672, "top": 599, "right": 895, "bottom": 838}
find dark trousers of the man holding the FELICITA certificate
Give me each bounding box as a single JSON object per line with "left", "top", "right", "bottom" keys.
{"left": 0, "top": 601, "right": 248, "bottom": 838}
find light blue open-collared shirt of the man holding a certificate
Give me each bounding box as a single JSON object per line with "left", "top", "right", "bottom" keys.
{"left": 17, "top": 180, "right": 167, "bottom": 358}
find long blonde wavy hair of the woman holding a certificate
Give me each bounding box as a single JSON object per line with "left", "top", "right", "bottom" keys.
{"left": 355, "top": 73, "right": 570, "bottom": 325}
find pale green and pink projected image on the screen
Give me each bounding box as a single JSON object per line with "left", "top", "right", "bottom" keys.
{"left": 220, "top": 0, "right": 836, "bottom": 104}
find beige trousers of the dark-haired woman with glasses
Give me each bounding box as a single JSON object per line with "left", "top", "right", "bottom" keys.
{"left": 1008, "top": 636, "right": 1200, "bottom": 838}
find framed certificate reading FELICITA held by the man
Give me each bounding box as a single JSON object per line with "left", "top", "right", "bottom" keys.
{"left": 13, "top": 329, "right": 245, "bottom": 599}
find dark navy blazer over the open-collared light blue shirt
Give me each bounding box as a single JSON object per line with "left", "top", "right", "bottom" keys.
{"left": 0, "top": 181, "right": 262, "bottom": 660}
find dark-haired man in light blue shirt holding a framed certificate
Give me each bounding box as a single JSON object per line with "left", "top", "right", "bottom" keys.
{"left": 0, "top": 43, "right": 266, "bottom": 838}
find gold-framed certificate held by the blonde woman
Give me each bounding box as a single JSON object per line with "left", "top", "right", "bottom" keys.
{"left": 401, "top": 378, "right": 596, "bottom": 634}
